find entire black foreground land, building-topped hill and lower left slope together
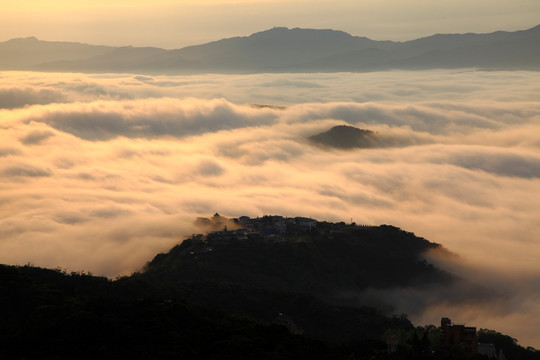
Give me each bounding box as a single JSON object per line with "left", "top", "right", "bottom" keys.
{"left": 0, "top": 214, "right": 540, "bottom": 359}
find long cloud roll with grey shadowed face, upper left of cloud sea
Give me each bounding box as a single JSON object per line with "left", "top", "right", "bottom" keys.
{"left": 25, "top": 99, "right": 276, "bottom": 141}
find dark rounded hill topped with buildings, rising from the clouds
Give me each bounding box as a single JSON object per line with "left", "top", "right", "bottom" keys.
{"left": 140, "top": 214, "right": 455, "bottom": 292}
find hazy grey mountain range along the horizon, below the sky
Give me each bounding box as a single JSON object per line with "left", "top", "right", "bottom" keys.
{"left": 0, "top": 25, "right": 540, "bottom": 74}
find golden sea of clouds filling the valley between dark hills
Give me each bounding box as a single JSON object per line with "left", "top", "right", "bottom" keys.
{"left": 0, "top": 70, "right": 540, "bottom": 347}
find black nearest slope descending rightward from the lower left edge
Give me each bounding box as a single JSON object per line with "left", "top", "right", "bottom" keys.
{"left": 0, "top": 265, "right": 358, "bottom": 360}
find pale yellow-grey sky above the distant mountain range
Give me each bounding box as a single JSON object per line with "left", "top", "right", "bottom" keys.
{"left": 0, "top": 0, "right": 540, "bottom": 49}
